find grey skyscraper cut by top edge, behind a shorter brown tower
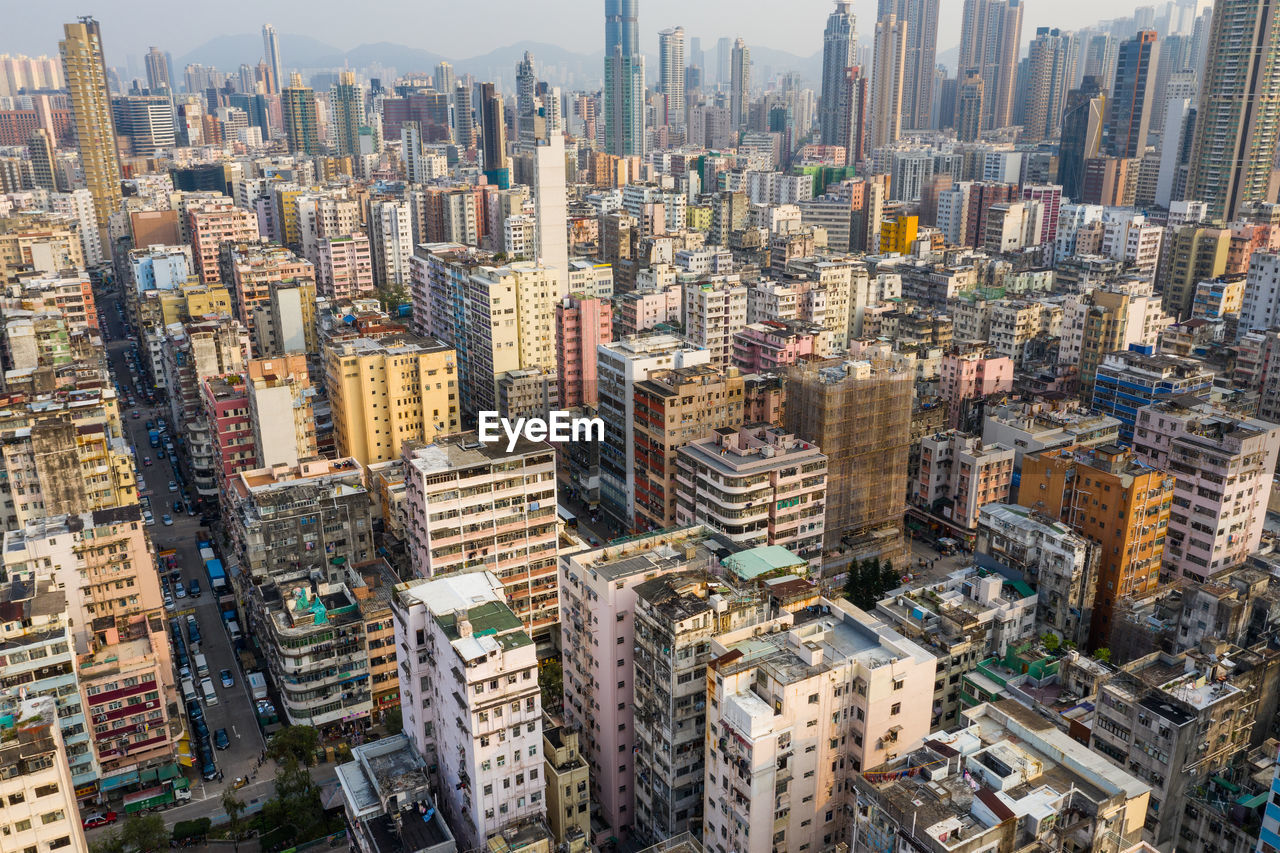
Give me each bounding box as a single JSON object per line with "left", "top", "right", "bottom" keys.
{"left": 957, "top": 0, "right": 1023, "bottom": 131}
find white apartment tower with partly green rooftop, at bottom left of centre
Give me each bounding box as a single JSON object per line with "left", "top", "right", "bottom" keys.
{"left": 393, "top": 571, "right": 547, "bottom": 850}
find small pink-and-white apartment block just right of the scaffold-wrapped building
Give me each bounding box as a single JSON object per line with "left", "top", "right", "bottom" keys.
{"left": 914, "top": 429, "right": 1015, "bottom": 532}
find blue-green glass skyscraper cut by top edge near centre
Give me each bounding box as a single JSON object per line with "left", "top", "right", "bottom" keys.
{"left": 604, "top": 0, "right": 645, "bottom": 156}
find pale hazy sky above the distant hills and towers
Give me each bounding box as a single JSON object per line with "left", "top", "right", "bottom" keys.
{"left": 0, "top": 0, "right": 1164, "bottom": 64}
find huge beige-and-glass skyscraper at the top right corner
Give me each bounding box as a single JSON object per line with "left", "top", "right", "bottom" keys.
{"left": 1187, "top": 0, "right": 1280, "bottom": 219}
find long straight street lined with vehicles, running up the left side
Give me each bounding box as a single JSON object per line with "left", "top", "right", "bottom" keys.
{"left": 99, "top": 286, "right": 270, "bottom": 812}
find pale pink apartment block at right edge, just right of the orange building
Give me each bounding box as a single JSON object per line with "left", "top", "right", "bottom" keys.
{"left": 1133, "top": 396, "right": 1280, "bottom": 581}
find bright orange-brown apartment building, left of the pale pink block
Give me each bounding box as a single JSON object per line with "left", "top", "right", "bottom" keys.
{"left": 1018, "top": 444, "right": 1174, "bottom": 651}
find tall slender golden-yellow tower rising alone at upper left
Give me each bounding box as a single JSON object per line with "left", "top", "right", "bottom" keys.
{"left": 58, "top": 18, "right": 124, "bottom": 254}
